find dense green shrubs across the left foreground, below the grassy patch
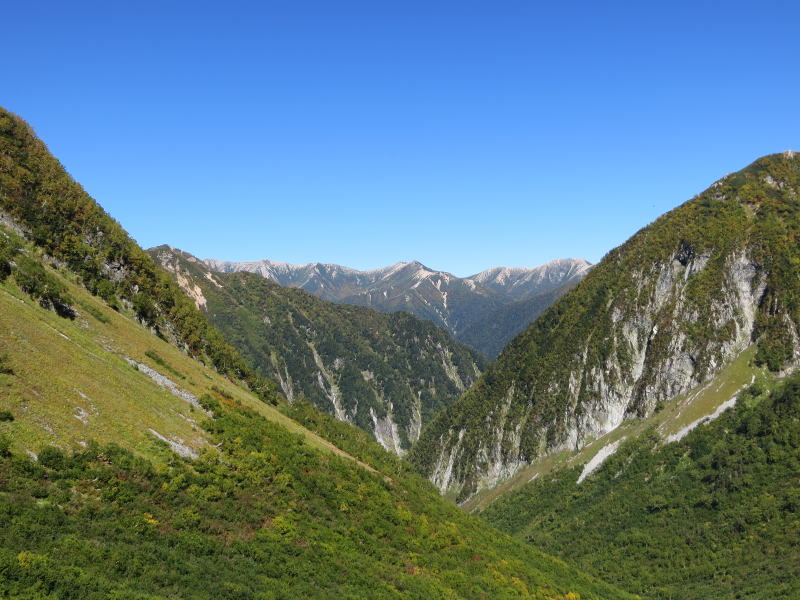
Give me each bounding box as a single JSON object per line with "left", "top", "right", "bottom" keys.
{"left": 0, "top": 372, "right": 627, "bottom": 600}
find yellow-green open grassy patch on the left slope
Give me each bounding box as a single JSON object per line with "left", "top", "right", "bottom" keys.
{"left": 0, "top": 234, "right": 340, "bottom": 457}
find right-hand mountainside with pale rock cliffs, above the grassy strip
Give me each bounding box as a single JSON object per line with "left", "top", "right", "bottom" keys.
{"left": 412, "top": 152, "right": 800, "bottom": 500}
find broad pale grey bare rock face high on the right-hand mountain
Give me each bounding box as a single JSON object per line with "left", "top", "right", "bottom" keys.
{"left": 553, "top": 254, "right": 766, "bottom": 448}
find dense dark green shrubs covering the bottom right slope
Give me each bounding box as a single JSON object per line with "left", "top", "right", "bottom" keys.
{"left": 481, "top": 375, "right": 800, "bottom": 600}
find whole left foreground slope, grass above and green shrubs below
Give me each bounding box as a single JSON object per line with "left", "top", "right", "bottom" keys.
{"left": 0, "top": 228, "right": 628, "bottom": 599}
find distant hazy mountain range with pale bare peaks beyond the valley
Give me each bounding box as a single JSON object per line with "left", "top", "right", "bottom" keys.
{"left": 206, "top": 259, "right": 590, "bottom": 345}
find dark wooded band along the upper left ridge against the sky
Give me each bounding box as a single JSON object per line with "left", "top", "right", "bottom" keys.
{"left": 0, "top": 108, "right": 274, "bottom": 399}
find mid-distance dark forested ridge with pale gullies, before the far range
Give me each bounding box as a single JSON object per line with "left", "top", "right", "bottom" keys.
{"left": 150, "top": 246, "right": 483, "bottom": 454}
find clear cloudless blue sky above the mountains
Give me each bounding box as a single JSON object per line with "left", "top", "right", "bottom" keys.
{"left": 0, "top": 0, "right": 800, "bottom": 275}
